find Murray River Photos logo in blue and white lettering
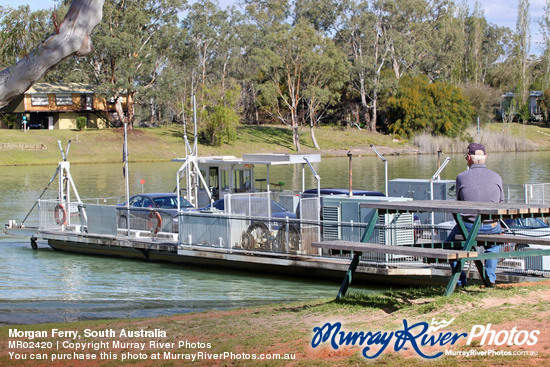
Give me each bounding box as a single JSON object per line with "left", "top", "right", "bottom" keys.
{"left": 311, "top": 318, "right": 540, "bottom": 359}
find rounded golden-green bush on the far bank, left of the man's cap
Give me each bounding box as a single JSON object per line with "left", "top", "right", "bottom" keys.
{"left": 388, "top": 76, "right": 473, "bottom": 137}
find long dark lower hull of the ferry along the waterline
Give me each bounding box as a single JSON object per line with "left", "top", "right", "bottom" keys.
{"left": 48, "top": 239, "right": 536, "bottom": 286}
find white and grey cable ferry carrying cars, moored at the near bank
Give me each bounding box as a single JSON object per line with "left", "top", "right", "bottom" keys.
{"left": 5, "top": 137, "right": 548, "bottom": 285}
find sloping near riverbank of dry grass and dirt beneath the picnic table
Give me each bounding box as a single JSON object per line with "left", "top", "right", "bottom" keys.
{"left": 0, "top": 281, "right": 550, "bottom": 366}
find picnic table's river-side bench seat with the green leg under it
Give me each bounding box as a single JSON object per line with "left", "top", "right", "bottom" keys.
{"left": 311, "top": 241, "right": 478, "bottom": 299}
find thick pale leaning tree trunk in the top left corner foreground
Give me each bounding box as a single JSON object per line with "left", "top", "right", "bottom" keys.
{"left": 0, "top": 0, "right": 105, "bottom": 108}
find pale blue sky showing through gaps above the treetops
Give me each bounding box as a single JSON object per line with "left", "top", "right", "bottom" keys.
{"left": 0, "top": 0, "right": 546, "bottom": 54}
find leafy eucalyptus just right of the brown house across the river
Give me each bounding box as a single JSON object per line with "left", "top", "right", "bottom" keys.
{"left": 92, "top": 0, "right": 184, "bottom": 126}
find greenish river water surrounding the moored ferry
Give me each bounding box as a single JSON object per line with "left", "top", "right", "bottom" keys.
{"left": 0, "top": 152, "right": 550, "bottom": 324}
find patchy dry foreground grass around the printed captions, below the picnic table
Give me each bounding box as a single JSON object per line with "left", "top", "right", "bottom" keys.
{"left": 0, "top": 282, "right": 550, "bottom": 366}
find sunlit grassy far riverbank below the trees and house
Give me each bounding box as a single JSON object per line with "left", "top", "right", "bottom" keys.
{"left": 0, "top": 124, "right": 550, "bottom": 165}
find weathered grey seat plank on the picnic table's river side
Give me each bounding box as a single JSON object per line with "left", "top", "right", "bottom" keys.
{"left": 311, "top": 241, "right": 477, "bottom": 260}
